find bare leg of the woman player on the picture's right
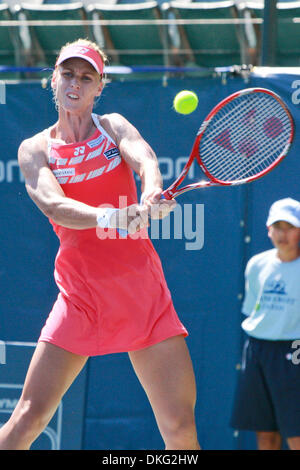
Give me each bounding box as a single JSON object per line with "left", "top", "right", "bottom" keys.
{"left": 129, "top": 336, "right": 200, "bottom": 449}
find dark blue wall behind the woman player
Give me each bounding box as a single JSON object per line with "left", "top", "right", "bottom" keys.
{"left": 0, "top": 73, "right": 300, "bottom": 449}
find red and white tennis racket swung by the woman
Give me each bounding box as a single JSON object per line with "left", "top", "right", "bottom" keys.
{"left": 162, "top": 88, "right": 294, "bottom": 199}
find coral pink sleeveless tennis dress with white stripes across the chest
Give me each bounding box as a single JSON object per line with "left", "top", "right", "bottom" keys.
{"left": 39, "top": 114, "right": 187, "bottom": 356}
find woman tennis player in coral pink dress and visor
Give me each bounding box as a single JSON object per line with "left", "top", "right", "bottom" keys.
{"left": 0, "top": 40, "right": 199, "bottom": 449}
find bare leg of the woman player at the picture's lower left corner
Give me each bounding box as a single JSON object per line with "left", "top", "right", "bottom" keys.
{"left": 0, "top": 342, "right": 87, "bottom": 450}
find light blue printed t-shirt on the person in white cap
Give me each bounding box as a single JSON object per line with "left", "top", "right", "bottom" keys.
{"left": 242, "top": 249, "right": 300, "bottom": 340}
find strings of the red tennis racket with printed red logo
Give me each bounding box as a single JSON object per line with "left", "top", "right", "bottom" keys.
{"left": 199, "top": 93, "right": 291, "bottom": 181}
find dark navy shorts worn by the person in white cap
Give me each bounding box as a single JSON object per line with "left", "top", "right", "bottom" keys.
{"left": 230, "top": 337, "right": 300, "bottom": 438}
